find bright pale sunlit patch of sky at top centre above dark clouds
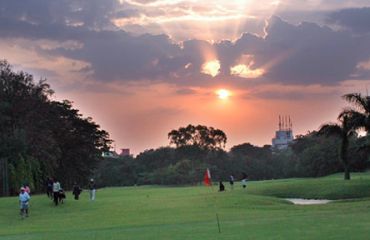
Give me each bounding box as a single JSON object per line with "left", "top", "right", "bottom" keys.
{"left": 111, "top": 0, "right": 283, "bottom": 41}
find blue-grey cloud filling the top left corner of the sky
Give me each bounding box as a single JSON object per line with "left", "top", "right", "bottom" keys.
{"left": 0, "top": 0, "right": 120, "bottom": 29}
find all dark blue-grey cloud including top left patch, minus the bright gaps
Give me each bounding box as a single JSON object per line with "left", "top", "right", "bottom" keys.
{"left": 0, "top": 0, "right": 370, "bottom": 86}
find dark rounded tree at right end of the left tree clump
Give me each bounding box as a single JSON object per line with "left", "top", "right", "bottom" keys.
{"left": 49, "top": 100, "right": 111, "bottom": 188}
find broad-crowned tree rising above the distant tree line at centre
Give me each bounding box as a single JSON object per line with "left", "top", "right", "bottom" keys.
{"left": 168, "top": 124, "right": 227, "bottom": 149}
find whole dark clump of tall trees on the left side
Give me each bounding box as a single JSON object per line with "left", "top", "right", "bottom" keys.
{"left": 0, "top": 60, "right": 111, "bottom": 195}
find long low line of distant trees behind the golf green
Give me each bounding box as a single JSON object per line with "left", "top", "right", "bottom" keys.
{"left": 95, "top": 131, "right": 370, "bottom": 187}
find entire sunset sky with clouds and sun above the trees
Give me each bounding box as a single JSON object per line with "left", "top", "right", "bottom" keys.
{"left": 0, "top": 0, "right": 370, "bottom": 154}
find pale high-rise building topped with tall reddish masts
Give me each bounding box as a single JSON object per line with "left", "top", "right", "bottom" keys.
{"left": 272, "top": 116, "right": 293, "bottom": 150}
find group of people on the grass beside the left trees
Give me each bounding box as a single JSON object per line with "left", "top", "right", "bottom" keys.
{"left": 19, "top": 178, "right": 96, "bottom": 219}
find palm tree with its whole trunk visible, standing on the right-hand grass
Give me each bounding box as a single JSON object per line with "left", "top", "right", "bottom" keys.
{"left": 318, "top": 113, "right": 355, "bottom": 180}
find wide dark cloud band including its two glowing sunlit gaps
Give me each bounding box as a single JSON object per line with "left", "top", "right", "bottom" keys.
{"left": 0, "top": 17, "right": 370, "bottom": 85}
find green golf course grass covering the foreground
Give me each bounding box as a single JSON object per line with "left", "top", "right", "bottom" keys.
{"left": 0, "top": 173, "right": 370, "bottom": 240}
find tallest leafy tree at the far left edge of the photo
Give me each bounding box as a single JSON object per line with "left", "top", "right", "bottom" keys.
{"left": 0, "top": 61, "right": 54, "bottom": 195}
